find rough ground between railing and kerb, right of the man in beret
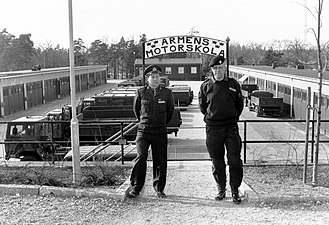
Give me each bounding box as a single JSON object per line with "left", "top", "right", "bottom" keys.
{"left": 244, "top": 165, "right": 329, "bottom": 198}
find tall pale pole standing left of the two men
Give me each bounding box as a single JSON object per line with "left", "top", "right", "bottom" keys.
{"left": 68, "top": 0, "right": 81, "bottom": 185}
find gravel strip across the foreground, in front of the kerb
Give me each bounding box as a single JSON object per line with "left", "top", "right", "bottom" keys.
{"left": 0, "top": 188, "right": 329, "bottom": 225}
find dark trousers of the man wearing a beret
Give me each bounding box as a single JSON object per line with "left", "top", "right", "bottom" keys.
{"left": 206, "top": 125, "right": 243, "bottom": 193}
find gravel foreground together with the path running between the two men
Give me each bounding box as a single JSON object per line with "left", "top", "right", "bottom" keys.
{"left": 0, "top": 162, "right": 329, "bottom": 225}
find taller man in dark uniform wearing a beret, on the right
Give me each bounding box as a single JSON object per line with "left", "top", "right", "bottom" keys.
{"left": 199, "top": 55, "right": 243, "bottom": 204}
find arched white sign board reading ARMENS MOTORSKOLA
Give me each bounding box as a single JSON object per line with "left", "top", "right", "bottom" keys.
{"left": 145, "top": 35, "right": 227, "bottom": 59}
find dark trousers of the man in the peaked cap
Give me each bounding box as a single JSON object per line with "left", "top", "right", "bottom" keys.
{"left": 130, "top": 131, "right": 168, "bottom": 192}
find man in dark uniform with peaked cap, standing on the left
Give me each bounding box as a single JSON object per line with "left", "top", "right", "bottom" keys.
{"left": 128, "top": 65, "right": 174, "bottom": 198}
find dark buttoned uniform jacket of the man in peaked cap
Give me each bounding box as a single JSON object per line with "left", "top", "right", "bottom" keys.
{"left": 134, "top": 86, "right": 174, "bottom": 134}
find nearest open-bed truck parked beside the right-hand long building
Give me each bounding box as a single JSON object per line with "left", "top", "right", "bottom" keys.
{"left": 249, "top": 90, "right": 283, "bottom": 116}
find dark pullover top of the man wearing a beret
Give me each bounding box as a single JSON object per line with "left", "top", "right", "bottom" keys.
{"left": 199, "top": 77, "right": 243, "bottom": 127}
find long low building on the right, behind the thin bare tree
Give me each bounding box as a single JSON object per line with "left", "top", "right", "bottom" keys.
{"left": 229, "top": 66, "right": 329, "bottom": 133}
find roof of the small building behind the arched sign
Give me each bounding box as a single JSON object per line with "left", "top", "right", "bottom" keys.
{"left": 135, "top": 58, "right": 202, "bottom": 65}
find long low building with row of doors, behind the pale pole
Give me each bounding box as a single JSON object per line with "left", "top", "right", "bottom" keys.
{"left": 0, "top": 65, "right": 107, "bottom": 117}
